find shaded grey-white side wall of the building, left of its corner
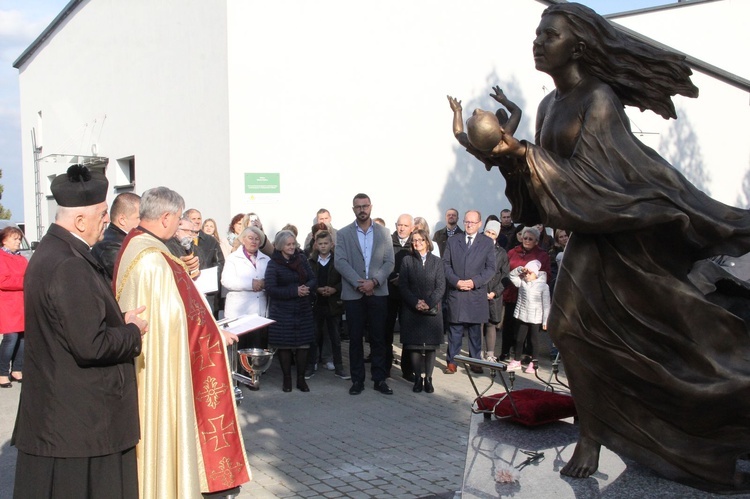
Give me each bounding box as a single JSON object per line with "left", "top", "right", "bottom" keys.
{"left": 19, "top": 0, "right": 229, "bottom": 240}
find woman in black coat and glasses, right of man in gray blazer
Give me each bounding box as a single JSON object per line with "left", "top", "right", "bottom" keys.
{"left": 398, "top": 229, "right": 445, "bottom": 393}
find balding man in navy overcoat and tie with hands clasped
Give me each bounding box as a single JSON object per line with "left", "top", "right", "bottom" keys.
{"left": 443, "top": 210, "right": 496, "bottom": 374}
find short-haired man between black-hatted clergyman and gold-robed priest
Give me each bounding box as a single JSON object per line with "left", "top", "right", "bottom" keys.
{"left": 91, "top": 192, "right": 141, "bottom": 281}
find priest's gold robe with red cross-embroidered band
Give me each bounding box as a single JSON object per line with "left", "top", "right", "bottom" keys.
{"left": 113, "top": 228, "right": 250, "bottom": 499}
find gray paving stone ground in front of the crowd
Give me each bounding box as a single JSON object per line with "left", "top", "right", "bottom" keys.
{"left": 0, "top": 335, "right": 560, "bottom": 499}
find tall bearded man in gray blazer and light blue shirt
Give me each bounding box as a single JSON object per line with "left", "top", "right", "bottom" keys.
{"left": 334, "top": 193, "right": 394, "bottom": 395}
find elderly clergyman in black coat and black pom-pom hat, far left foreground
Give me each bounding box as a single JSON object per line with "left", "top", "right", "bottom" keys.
{"left": 11, "top": 165, "right": 147, "bottom": 498}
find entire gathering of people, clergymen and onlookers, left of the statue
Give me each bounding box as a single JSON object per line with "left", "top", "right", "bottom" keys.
{"left": 0, "top": 167, "right": 567, "bottom": 497}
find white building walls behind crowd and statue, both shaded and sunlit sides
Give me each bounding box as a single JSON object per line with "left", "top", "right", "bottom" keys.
{"left": 21, "top": 0, "right": 750, "bottom": 242}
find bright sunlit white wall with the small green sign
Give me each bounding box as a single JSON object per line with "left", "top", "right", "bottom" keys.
{"left": 228, "top": 0, "right": 550, "bottom": 237}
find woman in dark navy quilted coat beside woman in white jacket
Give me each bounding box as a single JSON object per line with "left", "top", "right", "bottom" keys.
{"left": 266, "top": 230, "right": 316, "bottom": 392}
